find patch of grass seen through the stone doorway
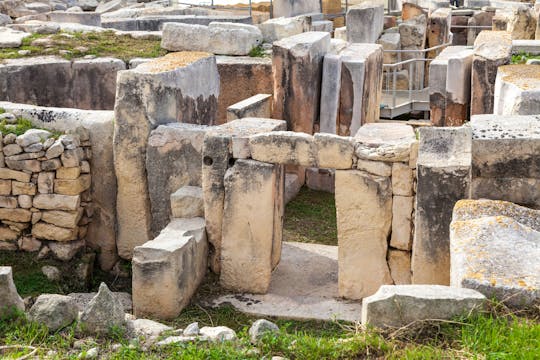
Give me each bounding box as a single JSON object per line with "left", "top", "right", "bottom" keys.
{"left": 283, "top": 187, "right": 337, "bottom": 245}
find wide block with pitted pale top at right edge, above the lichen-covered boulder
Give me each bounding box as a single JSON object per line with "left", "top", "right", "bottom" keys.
{"left": 471, "top": 114, "right": 540, "bottom": 208}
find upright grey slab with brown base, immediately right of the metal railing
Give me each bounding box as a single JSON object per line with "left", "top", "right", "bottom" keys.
{"left": 429, "top": 46, "right": 473, "bottom": 126}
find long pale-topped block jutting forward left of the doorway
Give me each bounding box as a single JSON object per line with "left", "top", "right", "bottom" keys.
{"left": 132, "top": 218, "right": 208, "bottom": 319}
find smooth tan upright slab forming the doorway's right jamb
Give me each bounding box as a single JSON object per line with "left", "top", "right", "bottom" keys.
{"left": 336, "top": 170, "right": 392, "bottom": 299}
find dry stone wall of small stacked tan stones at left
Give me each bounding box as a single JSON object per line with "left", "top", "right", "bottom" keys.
{"left": 0, "top": 125, "right": 93, "bottom": 261}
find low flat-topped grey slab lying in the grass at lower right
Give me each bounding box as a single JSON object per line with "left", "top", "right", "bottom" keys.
{"left": 362, "top": 285, "right": 486, "bottom": 328}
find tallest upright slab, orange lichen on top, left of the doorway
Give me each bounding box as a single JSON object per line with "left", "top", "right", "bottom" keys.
{"left": 114, "top": 52, "right": 219, "bottom": 259}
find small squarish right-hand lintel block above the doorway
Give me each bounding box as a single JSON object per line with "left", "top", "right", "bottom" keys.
{"left": 313, "top": 133, "right": 354, "bottom": 169}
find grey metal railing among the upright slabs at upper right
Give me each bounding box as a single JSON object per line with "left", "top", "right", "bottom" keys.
{"left": 381, "top": 39, "right": 452, "bottom": 119}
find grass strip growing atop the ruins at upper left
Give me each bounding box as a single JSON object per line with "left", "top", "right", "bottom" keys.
{"left": 0, "top": 31, "right": 167, "bottom": 62}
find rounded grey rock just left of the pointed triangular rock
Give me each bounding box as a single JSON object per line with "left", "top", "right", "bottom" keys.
{"left": 28, "top": 294, "right": 78, "bottom": 332}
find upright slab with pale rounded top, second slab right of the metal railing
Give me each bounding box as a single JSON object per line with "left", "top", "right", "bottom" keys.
{"left": 471, "top": 31, "right": 512, "bottom": 116}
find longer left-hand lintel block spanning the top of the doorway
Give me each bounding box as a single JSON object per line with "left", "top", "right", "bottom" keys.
{"left": 249, "top": 131, "right": 317, "bottom": 167}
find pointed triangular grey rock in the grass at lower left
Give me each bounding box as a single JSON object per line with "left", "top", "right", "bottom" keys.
{"left": 79, "top": 283, "right": 125, "bottom": 335}
